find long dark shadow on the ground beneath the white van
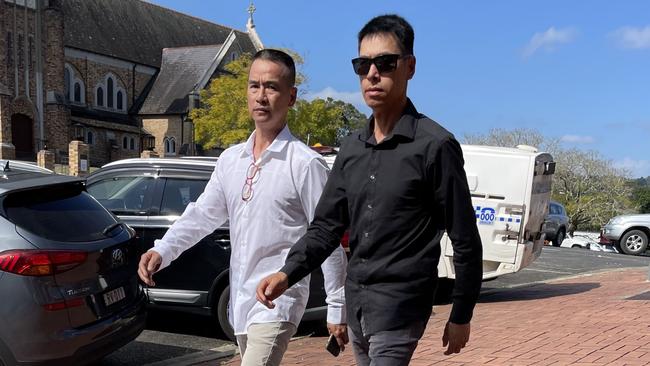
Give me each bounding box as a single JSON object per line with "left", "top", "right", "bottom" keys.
{"left": 478, "top": 282, "right": 600, "bottom": 303}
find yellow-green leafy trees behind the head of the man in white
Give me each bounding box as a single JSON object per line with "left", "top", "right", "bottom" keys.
{"left": 190, "top": 52, "right": 366, "bottom": 148}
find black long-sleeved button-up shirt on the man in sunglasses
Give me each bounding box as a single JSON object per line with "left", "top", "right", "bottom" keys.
{"left": 281, "top": 100, "right": 482, "bottom": 333}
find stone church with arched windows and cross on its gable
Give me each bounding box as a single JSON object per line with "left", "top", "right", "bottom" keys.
{"left": 0, "top": 0, "right": 263, "bottom": 166}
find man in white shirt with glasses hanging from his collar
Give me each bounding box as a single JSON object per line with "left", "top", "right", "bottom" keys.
{"left": 138, "top": 49, "right": 348, "bottom": 366}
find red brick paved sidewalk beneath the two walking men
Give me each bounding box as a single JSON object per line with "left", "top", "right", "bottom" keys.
{"left": 222, "top": 269, "right": 650, "bottom": 366}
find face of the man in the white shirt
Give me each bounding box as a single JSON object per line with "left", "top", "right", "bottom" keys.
{"left": 247, "top": 59, "right": 296, "bottom": 130}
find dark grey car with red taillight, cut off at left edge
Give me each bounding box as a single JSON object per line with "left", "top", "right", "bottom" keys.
{"left": 0, "top": 161, "right": 146, "bottom": 366}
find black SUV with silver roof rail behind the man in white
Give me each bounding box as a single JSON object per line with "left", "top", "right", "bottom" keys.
{"left": 86, "top": 158, "right": 336, "bottom": 340}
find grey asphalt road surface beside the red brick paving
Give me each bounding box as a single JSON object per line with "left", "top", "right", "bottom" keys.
{"left": 94, "top": 246, "right": 650, "bottom": 366}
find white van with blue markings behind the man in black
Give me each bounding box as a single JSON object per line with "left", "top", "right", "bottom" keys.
{"left": 438, "top": 145, "right": 555, "bottom": 280}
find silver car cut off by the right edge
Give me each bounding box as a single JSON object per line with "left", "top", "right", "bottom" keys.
{"left": 601, "top": 214, "right": 650, "bottom": 255}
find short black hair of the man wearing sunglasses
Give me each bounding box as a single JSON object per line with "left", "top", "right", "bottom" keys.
{"left": 359, "top": 14, "right": 415, "bottom": 55}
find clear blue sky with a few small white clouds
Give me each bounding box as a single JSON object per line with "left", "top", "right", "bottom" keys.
{"left": 152, "top": 0, "right": 650, "bottom": 177}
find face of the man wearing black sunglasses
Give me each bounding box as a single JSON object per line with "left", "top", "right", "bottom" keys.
{"left": 359, "top": 33, "right": 415, "bottom": 111}
